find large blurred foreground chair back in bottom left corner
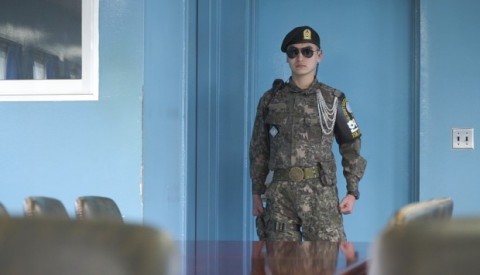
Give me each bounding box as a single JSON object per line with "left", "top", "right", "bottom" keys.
{"left": 0, "top": 218, "right": 176, "bottom": 275}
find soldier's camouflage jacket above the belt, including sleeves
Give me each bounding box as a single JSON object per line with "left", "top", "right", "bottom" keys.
{"left": 250, "top": 80, "right": 366, "bottom": 197}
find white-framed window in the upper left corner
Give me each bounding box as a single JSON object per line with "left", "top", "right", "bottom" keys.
{"left": 0, "top": 0, "right": 99, "bottom": 101}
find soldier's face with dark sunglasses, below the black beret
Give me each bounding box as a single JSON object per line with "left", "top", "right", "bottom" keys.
{"left": 287, "top": 43, "right": 323, "bottom": 76}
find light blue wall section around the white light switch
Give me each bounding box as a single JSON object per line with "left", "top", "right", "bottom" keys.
{"left": 420, "top": 0, "right": 480, "bottom": 216}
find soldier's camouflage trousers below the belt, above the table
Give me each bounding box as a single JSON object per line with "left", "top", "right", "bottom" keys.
{"left": 257, "top": 178, "right": 346, "bottom": 242}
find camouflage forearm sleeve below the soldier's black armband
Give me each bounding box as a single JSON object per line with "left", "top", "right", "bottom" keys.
{"left": 340, "top": 138, "right": 367, "bottom": 199}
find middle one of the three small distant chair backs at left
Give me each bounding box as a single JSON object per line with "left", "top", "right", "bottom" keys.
{"left": 24, "top": 196, "right": 69, "bottom": 219}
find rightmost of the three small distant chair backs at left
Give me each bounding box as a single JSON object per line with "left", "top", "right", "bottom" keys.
{"left": 75, "top": 196, "right": 123, "bottom": 222}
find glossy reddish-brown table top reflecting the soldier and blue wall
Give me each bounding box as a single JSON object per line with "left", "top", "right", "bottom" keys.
{"left": 184, "top": 241, "right": 369, "bottom": 275}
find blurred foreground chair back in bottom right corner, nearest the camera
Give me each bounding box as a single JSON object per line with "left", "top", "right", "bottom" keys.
{"left": 371, "top": 218, "right": 480, "bottom": 275}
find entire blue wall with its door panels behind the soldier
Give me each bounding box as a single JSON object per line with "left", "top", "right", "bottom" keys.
{"left": 0, "top": 0, "right": 480, "bottom": 244}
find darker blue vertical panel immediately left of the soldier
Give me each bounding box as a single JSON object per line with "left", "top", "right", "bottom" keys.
{"left": 196, "top": 1, "right": 253, "bottom": 240}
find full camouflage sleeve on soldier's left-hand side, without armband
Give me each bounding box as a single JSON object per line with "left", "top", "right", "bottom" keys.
{"left": 249, "top": 93, "right": 271, "bottom": 195}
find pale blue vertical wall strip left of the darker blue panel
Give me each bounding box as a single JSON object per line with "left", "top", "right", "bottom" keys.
{"left": 143, "top": 0, "right": 196, "bottom": 239}
